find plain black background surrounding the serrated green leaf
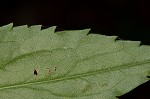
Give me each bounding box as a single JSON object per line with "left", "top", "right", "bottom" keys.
{"left": 0, "top": 0, "right": 150, "bottom": 99}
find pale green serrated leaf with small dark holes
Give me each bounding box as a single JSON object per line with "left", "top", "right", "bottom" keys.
{"left": 0, "top": 24, "right": 150, "bottom": 99}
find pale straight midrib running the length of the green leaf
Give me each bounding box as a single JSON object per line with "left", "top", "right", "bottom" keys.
{"left": 0, "top": 59, "right": 150, "bottom": 90}
